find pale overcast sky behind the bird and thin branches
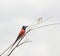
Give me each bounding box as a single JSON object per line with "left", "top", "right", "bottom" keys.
{"left": 0, "top": 0, "right": 60, "bottom": 56}
